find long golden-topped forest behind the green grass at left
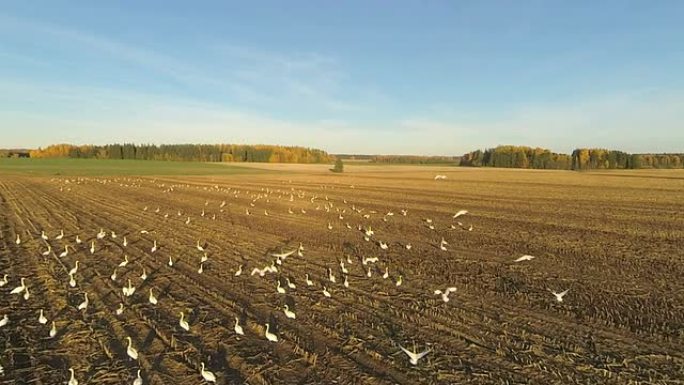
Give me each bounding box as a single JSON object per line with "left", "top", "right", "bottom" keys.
{"left": 29, "top": 143, "right": 333, "bottom": 163}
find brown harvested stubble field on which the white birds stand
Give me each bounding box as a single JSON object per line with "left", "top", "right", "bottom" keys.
{"left": 0, "top": 162, "right": 684, "bottom": 385}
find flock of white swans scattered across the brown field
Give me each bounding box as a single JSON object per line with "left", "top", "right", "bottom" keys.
{"left": 0, "top": 175, "right": 569, "bottom": 385}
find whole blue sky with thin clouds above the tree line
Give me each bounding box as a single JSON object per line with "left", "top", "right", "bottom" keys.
{"left": 0, "top": 0, "right": 684, "bottom": 155}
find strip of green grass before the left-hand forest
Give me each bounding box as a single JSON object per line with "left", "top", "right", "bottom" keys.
{"left": 0, "top": 158, "right": 268, "bottom": 176}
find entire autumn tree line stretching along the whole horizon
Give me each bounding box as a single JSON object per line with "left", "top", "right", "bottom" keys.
{"left": 0, "top": 143, "right": 684, "bottom": 170}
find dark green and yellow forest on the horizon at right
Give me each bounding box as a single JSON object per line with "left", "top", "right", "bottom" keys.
{"left": 460, "top": 146, "right": 684, "bottom": 170}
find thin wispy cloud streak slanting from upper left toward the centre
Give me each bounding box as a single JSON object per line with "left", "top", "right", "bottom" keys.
{"left": 0, "top": 16, "right": 384, "bottom": 115}
